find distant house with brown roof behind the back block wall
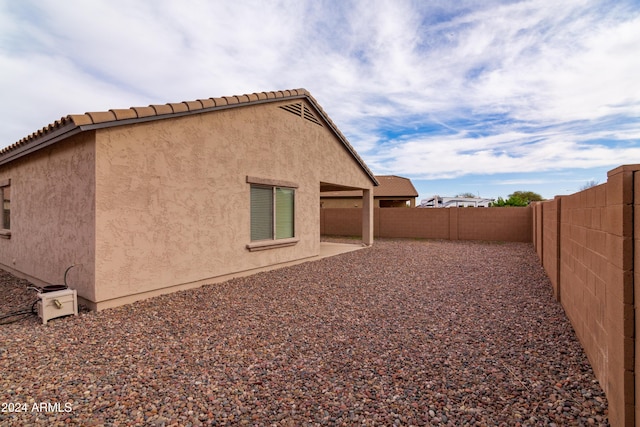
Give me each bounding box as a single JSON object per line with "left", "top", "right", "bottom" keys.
{"left": 320, "top": 175, "right": 418, "bottom": 208}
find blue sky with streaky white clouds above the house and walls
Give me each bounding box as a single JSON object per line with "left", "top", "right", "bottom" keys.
{"left": 0, "top": 0, "right": 640, "bottom": 198}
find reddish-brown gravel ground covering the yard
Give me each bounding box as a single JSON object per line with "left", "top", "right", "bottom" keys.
{"left": 0, "top": 240, "right": 608, "bottom": 426}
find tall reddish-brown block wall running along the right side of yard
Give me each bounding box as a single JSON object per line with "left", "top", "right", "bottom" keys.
{"left": 532, "top": 165, "right": 640, "bottom": 426}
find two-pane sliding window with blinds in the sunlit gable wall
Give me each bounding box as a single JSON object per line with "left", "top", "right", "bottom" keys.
{"left": 251, "top": 185, "right": 295, "bottom": 241}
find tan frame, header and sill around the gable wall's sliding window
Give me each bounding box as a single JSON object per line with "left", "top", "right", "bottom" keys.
{"left": 246, "top": 176, "right": 300, "bottom": 251}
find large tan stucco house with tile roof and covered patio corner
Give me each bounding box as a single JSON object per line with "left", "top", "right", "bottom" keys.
{"left": 0, "top": 89, "right": 377, "bottom": 310}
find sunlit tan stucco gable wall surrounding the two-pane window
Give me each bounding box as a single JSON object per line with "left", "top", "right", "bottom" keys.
{"left": 93, "top": 100, "right": 373, "bottom": 308}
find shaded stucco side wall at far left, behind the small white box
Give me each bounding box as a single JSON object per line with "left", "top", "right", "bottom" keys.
{"left": 0, "top": 132, "right": 95, "bottom": 299}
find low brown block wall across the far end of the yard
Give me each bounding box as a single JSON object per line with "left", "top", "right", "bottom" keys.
{"left": 320, "top": 208, "right": 533, "bottom": 242}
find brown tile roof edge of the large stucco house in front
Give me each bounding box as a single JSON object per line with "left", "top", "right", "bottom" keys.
{"left": 0, "top": 89, "right": 378, "bottom": 185}
